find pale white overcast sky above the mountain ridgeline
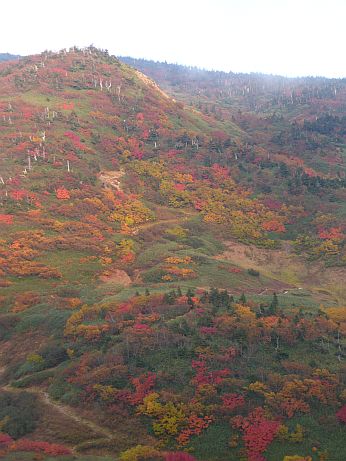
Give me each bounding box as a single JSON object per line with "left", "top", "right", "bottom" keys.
{"left": 0, "top": 0, "right": 346, "bottom": 77}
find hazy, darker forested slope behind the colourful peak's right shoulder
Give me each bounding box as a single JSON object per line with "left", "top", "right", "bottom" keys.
{"left": 120, "top": 57, "right": 346, "bottom": 176}
